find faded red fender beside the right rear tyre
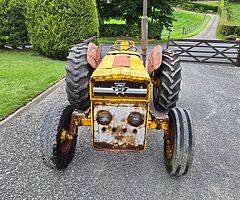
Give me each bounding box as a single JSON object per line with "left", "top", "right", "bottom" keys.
{"left": 148, "top": 45, "right": 162, "bottom": 75}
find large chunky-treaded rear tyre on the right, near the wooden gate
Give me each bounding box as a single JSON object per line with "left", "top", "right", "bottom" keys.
{"left": 153, "top": 50, "right": 182, "bottom": 111}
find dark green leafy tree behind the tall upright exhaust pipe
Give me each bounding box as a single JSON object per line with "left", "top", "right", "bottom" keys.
{"left": 98, "top": 0, "right": 179, "bottom": 28}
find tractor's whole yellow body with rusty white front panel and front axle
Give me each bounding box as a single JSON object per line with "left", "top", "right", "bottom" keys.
{"left": 70, "top": 41, "right": 168, "bottom": 151}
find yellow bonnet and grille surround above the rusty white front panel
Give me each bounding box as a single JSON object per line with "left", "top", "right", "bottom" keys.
{"left": 90, "top": 41, "right": 152, "bottom": 103}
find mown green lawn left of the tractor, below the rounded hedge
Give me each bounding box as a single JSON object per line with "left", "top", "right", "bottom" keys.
{"left": 0, "top": 50, "right": 66, "bottom": 120}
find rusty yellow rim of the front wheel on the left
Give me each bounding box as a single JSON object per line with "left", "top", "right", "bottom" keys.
{"left": 60, "top": 128, "right": 76, "bottom": 155}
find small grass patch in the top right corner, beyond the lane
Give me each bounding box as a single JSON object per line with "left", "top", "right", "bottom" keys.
{"left": 228, "top": 3, "right": 240, "bottom": 26}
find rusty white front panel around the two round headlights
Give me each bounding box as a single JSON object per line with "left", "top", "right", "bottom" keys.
{"left": 93, "top": 103, "right": 148, "bottom": 150}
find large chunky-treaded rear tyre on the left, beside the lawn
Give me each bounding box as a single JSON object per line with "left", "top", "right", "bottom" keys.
{"left": 66, "top": 43, "right": 93, "bottom": 111}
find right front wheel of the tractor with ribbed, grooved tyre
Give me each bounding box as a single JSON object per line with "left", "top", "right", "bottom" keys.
{"left": 164, "top": 108, "right": 195, "bottom": 176}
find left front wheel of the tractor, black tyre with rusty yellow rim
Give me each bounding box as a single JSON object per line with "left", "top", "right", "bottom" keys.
{"left": 40, "top": 105, "right": 77, "bottom": 169}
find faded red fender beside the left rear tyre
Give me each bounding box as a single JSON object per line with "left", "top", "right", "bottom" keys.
{"left": 87, "top": 42, "right": 101, "bottom": 69}
